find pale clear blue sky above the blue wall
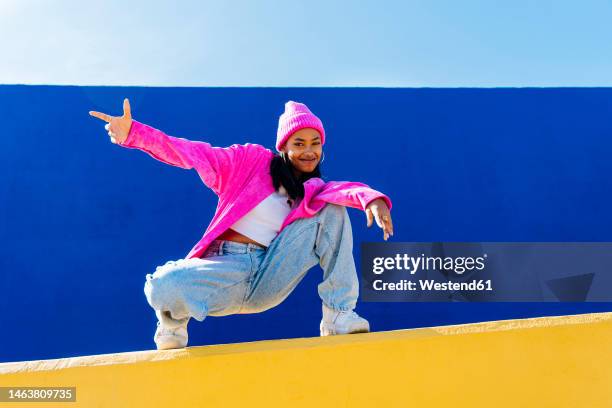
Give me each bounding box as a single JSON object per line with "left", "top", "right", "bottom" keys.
{"left": 0, "top": 0, "right": 612, "bottom": 87}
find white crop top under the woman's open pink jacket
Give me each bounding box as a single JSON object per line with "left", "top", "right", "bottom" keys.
{"left": 230, "top": 186, "right": 291, "bottom": 247}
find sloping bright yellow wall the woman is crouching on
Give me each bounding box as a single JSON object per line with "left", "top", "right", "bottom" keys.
{"left": 0, "top": 313, "right": 612, "bottom": 408}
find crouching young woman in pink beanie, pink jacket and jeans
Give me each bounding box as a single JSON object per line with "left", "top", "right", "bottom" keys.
{"left": 89, "top": 99, "right": 393, "bottom": 349}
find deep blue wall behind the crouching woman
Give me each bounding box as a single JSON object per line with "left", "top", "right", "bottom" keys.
{"left": 0, "top": 86, "right": 612, "bottom": 361}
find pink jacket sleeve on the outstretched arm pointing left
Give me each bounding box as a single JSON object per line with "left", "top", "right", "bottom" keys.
{"left": 119, "top": 120, "right": 243, "bottom": 195}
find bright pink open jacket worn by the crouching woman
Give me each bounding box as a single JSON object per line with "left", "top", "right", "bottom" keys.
{"left": 120, "top": 120, "right": 391, "bottom": 258}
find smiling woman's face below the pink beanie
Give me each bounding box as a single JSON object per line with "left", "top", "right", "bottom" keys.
{"left": 281, "top": 128, "right": 323, "bottom": 173}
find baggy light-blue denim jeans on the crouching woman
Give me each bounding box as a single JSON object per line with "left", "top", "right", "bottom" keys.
{"left": 144, "top": 203, "right": 359, "bottom": 327}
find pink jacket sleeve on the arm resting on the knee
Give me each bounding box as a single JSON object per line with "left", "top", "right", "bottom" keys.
{"left": 317, "top": 181, "right": 392, "bottom": 211}
